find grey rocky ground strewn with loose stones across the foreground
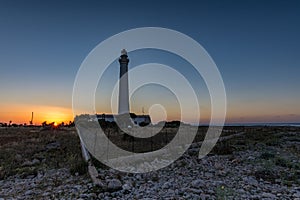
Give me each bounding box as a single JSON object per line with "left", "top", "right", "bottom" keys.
{"left": 0, "top": 128, "right": 300, "bottom": 199}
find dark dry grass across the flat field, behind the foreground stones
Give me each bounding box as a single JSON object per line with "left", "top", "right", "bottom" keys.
{"left": 0, "top": 127, "right": 300, "bottom": 184}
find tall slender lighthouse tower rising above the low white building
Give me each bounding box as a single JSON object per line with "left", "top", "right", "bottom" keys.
{"left": 118, "top": 49, "right": 129, "bottom": 115}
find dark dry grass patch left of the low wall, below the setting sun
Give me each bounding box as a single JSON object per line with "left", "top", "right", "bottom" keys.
{"left": 0, "top": 127, "right": 86, "bottom": 179}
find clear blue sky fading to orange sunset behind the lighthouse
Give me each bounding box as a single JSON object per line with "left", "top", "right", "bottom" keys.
{"left": 0, "top": 0, "right": 300, "bottom": 124}
